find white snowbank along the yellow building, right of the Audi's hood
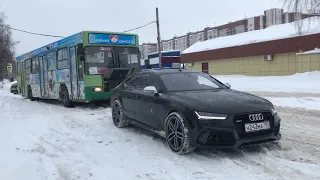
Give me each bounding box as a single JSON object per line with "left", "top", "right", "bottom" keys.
{"left": 213, "top": 71, "right": 320, "bottom": 93}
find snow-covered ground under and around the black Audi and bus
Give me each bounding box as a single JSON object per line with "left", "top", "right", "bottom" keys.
{"left": 0, "top": 76, "right": 320, "bottom": 180}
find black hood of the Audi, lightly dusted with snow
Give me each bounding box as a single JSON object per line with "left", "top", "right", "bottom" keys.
{"left": 169, "top": 89, "right": 273, "bottom": 114}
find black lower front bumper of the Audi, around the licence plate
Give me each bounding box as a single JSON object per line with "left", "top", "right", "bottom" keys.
{"left": 189, "top": 112, "right": 281, "bottom": 148}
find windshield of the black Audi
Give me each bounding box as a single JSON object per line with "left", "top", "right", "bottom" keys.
{"left": 161, "top": 73, "right": 225, "bottom": 91}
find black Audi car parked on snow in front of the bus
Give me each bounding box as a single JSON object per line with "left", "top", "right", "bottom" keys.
{"left": 111, "top": 69, "right": 281, "bottom": 154}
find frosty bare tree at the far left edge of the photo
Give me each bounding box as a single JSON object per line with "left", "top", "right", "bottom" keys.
{"left": 0, "top": 12, "right": 14, "bottom": 81}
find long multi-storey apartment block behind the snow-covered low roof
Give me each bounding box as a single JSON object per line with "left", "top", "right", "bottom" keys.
{"left": 158, "top": 8, "right": 313, "bottom": 51}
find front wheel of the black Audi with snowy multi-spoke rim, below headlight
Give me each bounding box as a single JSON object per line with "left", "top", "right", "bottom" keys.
{"left": 165, "top": 112, "right": 195, "bottom": 155}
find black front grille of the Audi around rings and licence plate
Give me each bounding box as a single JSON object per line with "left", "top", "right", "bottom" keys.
{"left": 233, "top": 112, "right": 274, "bottom": 138}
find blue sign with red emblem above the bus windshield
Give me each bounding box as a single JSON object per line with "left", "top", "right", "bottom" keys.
{"left": 89, "top": 33, "right": 136, "bottom": 46}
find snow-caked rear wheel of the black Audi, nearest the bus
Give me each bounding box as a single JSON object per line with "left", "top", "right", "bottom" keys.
{"left": 111, "top": 99, "right": 129, "bottom": 128}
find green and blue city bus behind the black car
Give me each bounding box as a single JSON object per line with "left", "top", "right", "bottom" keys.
{"left": 16, "top": 31, "right": 141, "bottom": 107}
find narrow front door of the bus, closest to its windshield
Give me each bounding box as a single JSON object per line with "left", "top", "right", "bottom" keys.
{"left": 69, "top": 47, "right": 79, "bottom": 100}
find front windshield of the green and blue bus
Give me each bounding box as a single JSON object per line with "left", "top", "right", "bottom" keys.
{"left": 85, "top": 47, "right": 139, "bottom": 74}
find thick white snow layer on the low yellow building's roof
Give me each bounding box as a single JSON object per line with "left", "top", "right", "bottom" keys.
{"left": 182, "top": 17, "right": 320, "bottom": 54}
